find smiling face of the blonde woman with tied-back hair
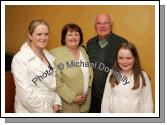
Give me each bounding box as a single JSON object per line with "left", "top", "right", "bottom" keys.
{"left": 29, "top": 24, "right": 49, "bottom": 49}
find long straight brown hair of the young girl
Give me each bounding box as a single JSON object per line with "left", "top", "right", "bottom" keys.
{"left": 109, "top": 42, "right": 146, "bottom": 90}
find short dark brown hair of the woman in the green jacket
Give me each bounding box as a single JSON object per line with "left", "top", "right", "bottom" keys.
{"left": 61, "top": 23, "right": 83, "bottom": 46}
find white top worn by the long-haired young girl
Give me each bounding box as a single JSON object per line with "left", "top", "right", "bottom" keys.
{"left": 101, "top": 72, "right": 153, "bottom": 113}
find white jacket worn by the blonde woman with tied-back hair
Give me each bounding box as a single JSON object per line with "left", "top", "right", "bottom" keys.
{"left": 11, "top": 42, "right": 62, "bottom": 113}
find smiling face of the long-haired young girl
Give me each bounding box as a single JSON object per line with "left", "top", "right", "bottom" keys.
{"left": 117, "top": 48, "right": 135, "bottom": 73}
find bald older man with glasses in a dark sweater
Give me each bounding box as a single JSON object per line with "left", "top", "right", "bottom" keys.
{"left": 87, "top": 14, "right": 127, "bottom": 113}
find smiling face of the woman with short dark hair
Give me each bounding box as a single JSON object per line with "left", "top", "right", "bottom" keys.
{"left": 65, "top": 30, "right": 80, "bottom": 49}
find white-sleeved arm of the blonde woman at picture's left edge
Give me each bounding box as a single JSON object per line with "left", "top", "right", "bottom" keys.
{"left": 12, "top": 58, "right": 44, "bottom": 112}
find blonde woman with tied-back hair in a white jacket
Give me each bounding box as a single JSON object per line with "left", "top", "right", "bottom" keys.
{"left": 12, "top": 20, "right": 61, "bottom": 113}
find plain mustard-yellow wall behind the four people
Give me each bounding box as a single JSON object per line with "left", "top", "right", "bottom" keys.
{"left": 5, "top": 5, "right": 155, "bottom": 110}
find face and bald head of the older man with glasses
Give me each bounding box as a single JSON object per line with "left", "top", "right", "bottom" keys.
{"left": 95, "top": 14, "right": 111, "bottom": 39}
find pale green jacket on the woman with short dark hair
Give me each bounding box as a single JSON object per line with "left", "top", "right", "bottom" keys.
{"left": 50, "top": 46, "right": 93, "bottom": 113}
